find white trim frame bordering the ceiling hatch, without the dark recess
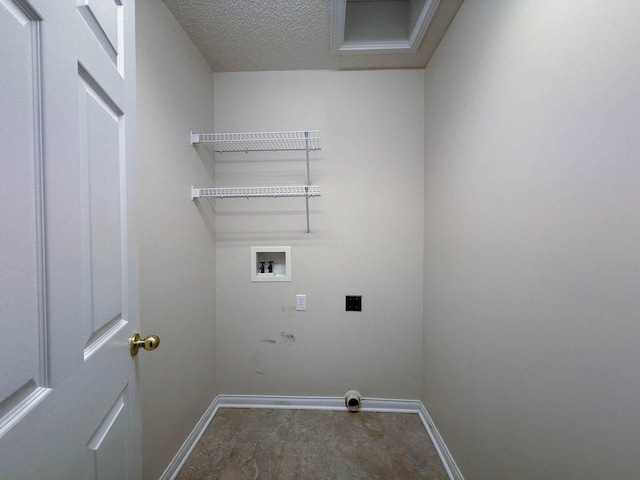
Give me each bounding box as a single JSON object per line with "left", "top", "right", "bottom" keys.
{"left": 331, "top": 0, "right": 440, "bottom": 55}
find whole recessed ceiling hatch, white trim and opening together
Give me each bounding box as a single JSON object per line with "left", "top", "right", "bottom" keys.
{"left": 331, "top": 0, "right": 440, "bottom": 55}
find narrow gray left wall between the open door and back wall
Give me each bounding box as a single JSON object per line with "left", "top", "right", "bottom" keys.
{"left": 136, "top": 0, "right": 217, "bottom": 479}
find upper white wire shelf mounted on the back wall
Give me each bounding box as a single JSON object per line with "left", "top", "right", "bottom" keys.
{"left": 191, "top": 130, "right": 320, "bottom": 152}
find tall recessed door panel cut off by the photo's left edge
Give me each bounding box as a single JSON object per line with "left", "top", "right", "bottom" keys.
{"left": 0, "top": 0, "right": 46, "bottom": 435}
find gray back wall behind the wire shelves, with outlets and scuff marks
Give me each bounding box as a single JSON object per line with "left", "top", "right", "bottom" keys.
{"left": 214, "top": 70, "right": 424, "bottom": 398}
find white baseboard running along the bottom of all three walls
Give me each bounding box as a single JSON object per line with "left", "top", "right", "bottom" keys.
{"left": 159, "top": 395, "right": 464, "bottom": 480}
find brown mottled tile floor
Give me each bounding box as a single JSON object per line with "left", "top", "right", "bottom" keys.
{"left": 177, "top": 408, "right": 448, "bottom": 480}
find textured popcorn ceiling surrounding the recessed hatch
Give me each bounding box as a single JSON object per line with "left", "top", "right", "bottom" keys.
{"left": 159, "top": 0, "right": 463, "bottom": 72}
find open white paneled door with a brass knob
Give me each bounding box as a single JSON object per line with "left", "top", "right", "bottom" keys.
{"left": 0, "top": 0, "right": 142, "bottom": 480}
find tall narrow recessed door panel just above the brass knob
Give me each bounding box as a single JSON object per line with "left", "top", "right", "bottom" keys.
{"left": 79, "top": 71, "right": 123, "bottom": 340}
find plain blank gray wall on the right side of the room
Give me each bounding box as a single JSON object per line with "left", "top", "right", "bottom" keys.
{"left": 422, "top": 0, "right": 640, "bottom": 480}
